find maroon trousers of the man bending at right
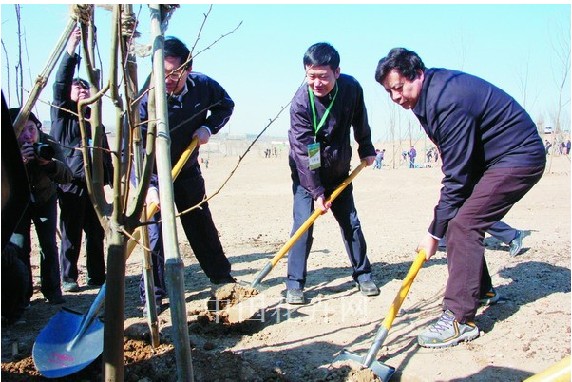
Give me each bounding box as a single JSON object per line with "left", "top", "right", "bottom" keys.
{"left": 443, "top": 166, "right": 544, "bottom": 323}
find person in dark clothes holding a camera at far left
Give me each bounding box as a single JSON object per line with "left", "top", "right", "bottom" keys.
{"left": 10, "top": 108, "right": 72, "bottom": 305}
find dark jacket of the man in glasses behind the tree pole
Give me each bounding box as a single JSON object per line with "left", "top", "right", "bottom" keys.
{"left": 139, "top": 72, "right": 234, "bottom": 183}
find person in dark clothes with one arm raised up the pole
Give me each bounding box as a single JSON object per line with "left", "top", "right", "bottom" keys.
{"left": 50, "top": 28, "right": 112, "bottom": 292}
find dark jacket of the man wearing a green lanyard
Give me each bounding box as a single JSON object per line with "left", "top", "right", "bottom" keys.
{"left": 288, "top": 74, "right": 375, "bottom": 199}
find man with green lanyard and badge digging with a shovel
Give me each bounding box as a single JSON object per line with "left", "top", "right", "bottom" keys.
{"left": 286, "top": 43, "right": 379, "bottom": 304}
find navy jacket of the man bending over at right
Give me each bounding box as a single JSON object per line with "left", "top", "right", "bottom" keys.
{"left": 412, "top": 69, "right": 546, "bottom": 238}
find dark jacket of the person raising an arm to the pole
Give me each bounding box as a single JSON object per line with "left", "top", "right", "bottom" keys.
{"left": 50, "top": 52, "right": 113, "bottom": 194}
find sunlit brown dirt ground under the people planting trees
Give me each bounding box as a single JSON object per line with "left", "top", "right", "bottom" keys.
{"left": 1, "top": 149, "right": 571, "bottom": 382}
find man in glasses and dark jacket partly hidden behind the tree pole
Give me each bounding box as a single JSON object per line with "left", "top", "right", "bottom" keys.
{"left": 139, "top": 37, "right": 236, "bottom": 314}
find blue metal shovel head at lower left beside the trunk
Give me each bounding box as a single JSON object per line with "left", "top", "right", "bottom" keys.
{"left": 32, "top": 308, "right": 103, "bottom": 378}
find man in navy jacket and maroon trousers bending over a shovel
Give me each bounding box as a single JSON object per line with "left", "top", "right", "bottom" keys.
{"left": 375, "top": 48, "right": 546, "bottom": 348}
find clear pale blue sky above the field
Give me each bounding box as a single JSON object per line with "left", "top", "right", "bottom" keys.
{"left": 1, "top": 3, "right": 571, "bottom": 141}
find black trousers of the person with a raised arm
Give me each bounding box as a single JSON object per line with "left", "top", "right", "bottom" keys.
{"left": 59, "top": 190, "right": 105, "bottom": 284}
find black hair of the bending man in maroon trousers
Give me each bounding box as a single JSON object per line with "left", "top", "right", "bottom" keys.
{"left": 375, "top": 48, "right": 426, "bottom": 84}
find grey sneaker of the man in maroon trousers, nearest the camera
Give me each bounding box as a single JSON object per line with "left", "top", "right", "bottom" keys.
{"left": 417, "top": 310, "right": 479, "bottom": 348}
